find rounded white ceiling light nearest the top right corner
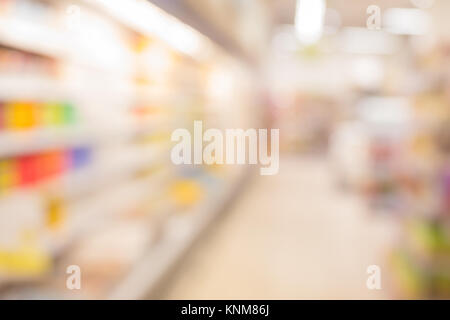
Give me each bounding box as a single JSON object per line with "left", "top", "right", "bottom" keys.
{"left": 383, "top": 8, "right": 432, "bottom": 35}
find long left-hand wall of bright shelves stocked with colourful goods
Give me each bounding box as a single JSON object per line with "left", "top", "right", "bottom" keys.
{"left": 0, "top": 0, "right": 254, "bottom": 298}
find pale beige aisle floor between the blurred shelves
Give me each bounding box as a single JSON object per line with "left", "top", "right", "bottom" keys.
{"left": 162, "top": 156, "right": 396, "bottom": 299}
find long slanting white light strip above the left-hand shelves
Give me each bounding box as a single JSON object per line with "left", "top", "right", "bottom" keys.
{"left": 89, "top": 0, "right": 210, "bottom": 58}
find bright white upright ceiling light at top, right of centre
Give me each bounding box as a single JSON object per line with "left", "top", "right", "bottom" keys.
{"left": 295, "top": 0, "right": 326, "bottom": 45}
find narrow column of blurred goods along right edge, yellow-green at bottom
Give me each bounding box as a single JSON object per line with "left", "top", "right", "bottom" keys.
{"left": 392, "top": 48, "right": 450, "bottom": 299}
